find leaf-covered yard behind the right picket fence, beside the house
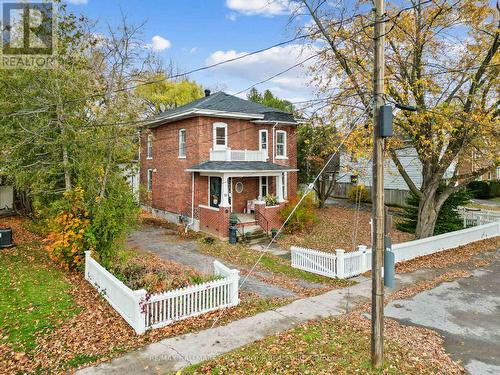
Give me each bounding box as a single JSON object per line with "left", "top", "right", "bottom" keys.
{"left": 278, "top": 206, "right": 415, "bottom": 252}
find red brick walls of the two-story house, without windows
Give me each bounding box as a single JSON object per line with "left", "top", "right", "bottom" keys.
{"left": 140, "top": 117, "right": 297, "bottom": 231}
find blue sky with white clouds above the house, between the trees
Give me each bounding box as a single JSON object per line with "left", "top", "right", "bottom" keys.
{"left": 66, "top": 0, "right": 314, "bottom": 101}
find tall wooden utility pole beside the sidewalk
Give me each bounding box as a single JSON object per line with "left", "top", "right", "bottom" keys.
{"left": 371, "top": 0, "right": 385, "bottom": 367}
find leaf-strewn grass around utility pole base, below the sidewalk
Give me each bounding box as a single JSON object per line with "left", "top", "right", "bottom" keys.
{"left": 183, "top": 313, "right": 464, "bottom": 374}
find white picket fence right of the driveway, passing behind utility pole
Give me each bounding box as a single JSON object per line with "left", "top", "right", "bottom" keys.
{"left": 290, "top": 221, "right": 500, "bottom": 279}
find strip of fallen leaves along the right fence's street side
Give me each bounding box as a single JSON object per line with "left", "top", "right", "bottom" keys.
{"left": 396, "top": 237, "right": 500, "bottom": 273}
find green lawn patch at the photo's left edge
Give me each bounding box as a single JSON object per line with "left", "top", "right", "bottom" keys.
{"left": 0, "top": 245, "right": 78, "bottom": 352}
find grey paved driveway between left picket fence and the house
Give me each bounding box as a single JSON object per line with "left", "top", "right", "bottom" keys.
{"left": 127, "top": 226, "right": 295, "bottom": 297}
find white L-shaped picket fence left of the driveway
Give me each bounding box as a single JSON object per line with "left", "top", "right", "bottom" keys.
{"left": 85, "top": 251, "right": 239, "bottom": 334}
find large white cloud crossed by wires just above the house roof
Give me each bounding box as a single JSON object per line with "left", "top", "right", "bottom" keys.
{"left": 205, "top": 44, "right": 316, "bottom": 98}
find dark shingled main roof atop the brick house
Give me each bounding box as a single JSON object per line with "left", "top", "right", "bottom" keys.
{"left": 151, "top": 91, "right": 296, "bottom": 123}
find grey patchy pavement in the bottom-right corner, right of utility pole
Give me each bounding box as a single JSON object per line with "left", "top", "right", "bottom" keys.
{"left": 385, "top": 250, "right": 500, "bottom": 375}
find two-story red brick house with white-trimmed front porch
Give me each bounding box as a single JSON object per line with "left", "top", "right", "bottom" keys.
{"left": 140, "top": 90, "right": 297, "bottom": 238}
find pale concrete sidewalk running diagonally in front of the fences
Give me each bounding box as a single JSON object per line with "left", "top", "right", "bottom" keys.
{"left": 77, "top": 278, "right": 371, "bottom": 374}
